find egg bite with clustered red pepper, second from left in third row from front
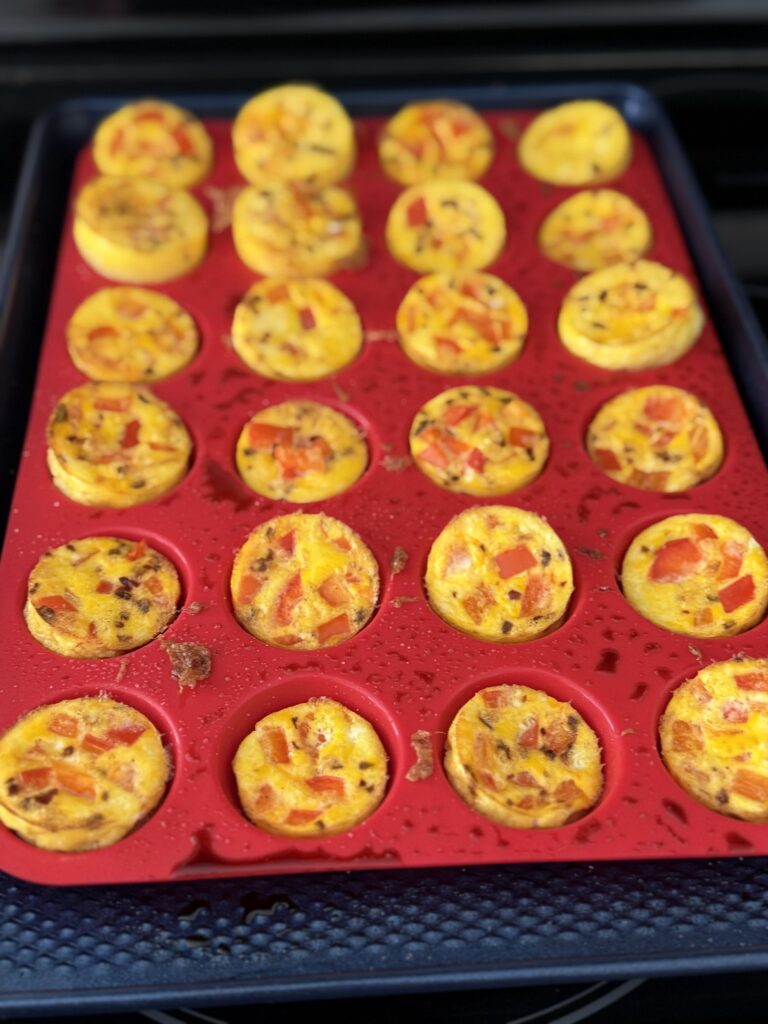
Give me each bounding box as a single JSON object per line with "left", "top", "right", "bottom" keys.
{"left": 236, "top": 401, "right": 368, "bottom": 504}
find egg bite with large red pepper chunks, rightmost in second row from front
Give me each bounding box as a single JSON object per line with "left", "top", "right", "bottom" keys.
{"left": 622, "top": 513, "right": 768, "bottom": 638}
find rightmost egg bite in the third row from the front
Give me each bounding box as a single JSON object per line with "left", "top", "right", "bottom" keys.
{"left": 587, "top": 384, "right": 723, "bottom": 494}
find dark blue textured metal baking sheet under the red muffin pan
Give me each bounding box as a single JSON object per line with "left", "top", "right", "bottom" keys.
{"left": 0, "top": 82, "right": 768, "bottom": 1017}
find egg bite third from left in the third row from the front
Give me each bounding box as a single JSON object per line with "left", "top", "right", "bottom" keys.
{"left": 410, "top": 384, "right": 549, "bottom": 498}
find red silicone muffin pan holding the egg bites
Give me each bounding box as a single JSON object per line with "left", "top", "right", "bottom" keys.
{"left": 0, "top": 111, "right": 768, "bottom": 884}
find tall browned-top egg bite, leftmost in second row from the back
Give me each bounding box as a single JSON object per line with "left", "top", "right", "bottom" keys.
{"left": 73, "top": 177, "right": 208, "bottom": 285}
